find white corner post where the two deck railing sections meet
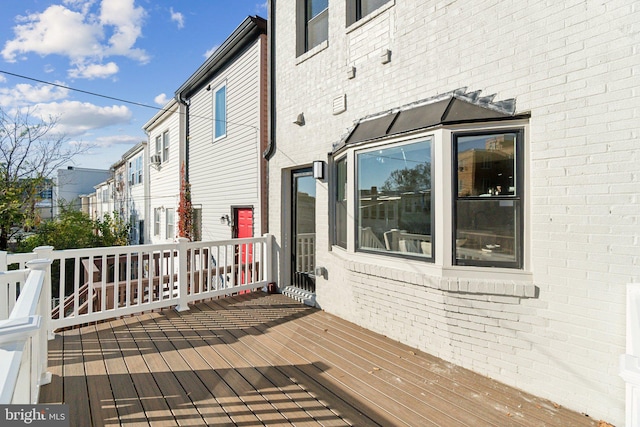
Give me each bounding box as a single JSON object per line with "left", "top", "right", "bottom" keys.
{"left": 27, "top": 258, "right": 53, "bottom": 392}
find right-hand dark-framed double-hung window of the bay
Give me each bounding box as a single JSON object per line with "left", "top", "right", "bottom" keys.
{"left": 454, "top": 132, "right": 522, "bottom": 266}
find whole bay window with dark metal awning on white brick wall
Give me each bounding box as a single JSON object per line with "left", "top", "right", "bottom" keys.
{"left": 331, "top": 93, "right": 529, "bottom": 274}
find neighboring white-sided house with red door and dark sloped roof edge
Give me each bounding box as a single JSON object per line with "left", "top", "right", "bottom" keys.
{"left": 174, "top": 17, "right": 268, "bottom": 244}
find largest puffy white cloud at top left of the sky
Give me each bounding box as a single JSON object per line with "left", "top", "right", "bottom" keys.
{"left": 0, "top": 0, "right": 149, "bottom": 78}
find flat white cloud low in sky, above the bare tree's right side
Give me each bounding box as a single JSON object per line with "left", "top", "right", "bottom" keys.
{"left": 25, "top": 101, "right": 132, "bottom": 137}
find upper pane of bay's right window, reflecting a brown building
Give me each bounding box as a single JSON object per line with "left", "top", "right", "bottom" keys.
{"left": 456, "top": 133, "right": 517, "bottom": 197}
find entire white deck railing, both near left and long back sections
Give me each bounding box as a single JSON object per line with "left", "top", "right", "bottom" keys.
{"left": 0, "top": 235, "right": 275, "bottom": 404}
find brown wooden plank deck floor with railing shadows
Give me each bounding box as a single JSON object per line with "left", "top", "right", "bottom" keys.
{"left": 40, "top": 293, "right": 597, "bottom": 427}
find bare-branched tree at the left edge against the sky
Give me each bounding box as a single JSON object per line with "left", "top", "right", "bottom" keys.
{"left": 0, "top": 108, "right": 85, "bottom": 250}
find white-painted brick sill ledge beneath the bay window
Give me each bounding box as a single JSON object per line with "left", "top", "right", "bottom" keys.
{"left": 331, "top": 250, "right": 538, "bottom": 298}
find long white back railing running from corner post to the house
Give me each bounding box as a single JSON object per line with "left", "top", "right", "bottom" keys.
{"left": 0, "top": 235, "right": 275, "bottom": 330}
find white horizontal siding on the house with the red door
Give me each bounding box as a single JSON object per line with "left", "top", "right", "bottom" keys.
{"left": 189, "top": 41, "right": 261, "bottom": 240}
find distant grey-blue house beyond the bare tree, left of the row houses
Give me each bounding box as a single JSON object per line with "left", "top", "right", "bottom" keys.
{"left": 53, "top": 166, "right": 111, "bottom": 217}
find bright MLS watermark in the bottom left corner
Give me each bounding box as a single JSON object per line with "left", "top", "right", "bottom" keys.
{"left": 0, "top": 405, "right": 69, "bottom": 427}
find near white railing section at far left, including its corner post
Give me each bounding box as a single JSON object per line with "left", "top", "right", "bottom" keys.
{"left": 0, "top": 259, "right": 51, "bottom": 404}
